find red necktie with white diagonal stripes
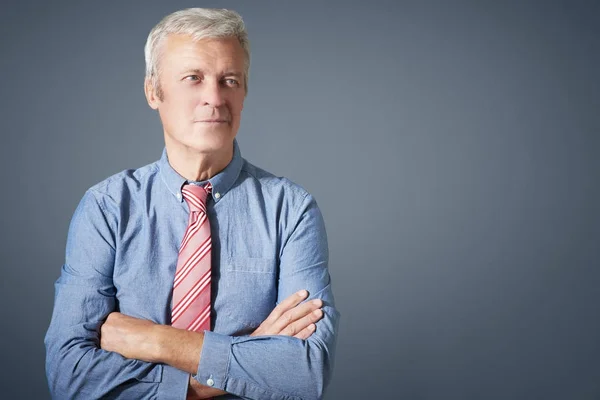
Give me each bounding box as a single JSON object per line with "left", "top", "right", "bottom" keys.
{"left": 171, "top": 182, "right": 212, "bottom": 332}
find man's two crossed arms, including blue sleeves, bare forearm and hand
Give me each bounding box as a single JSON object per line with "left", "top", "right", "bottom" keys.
{"left": 45, "top": 193, "right": 339, "bottom": 399}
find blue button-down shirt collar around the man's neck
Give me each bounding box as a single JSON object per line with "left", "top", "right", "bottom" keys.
{"left": 158, "top": 139, "right": 244, "bottom": 203}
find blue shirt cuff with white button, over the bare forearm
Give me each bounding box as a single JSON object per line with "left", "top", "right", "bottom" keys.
{"left": 195, "top": 331, "right": 233, "bottom": 390}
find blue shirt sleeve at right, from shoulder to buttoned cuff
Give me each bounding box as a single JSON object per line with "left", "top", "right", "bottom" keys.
{"left": 196, "top": 194, "right": 340, "bottom": 400}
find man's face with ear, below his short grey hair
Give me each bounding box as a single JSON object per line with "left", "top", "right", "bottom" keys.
{"left": 146, "top": 35, "right": 245, "bottom": 153}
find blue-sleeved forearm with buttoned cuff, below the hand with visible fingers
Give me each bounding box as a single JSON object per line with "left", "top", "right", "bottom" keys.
{"left": 196, "top": 306, "right": 338, "bottom": 399}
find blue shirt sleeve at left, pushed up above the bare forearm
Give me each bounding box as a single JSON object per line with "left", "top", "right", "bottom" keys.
{"left": 45, "top": 189, "right": 189, "bottom": 399}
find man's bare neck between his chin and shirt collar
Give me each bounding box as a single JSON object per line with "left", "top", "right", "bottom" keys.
{"left": 166, "top": 143, "right": 233, "bottom": 182}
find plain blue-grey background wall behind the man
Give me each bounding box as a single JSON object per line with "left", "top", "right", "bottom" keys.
{"left": 0, "top": 1, "right": 600, "bottom": 400}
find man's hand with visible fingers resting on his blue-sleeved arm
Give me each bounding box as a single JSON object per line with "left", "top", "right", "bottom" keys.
{"left": 250, "top": 290, "right": 323, "bottom": 340}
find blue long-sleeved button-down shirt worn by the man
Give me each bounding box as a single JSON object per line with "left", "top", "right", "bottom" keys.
{"left": 45, "top": 142, "right": 339, "bottom": 400}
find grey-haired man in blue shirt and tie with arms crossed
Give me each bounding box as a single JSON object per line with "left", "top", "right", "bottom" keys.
{"left": 45, "top": 9, "right": 339, "bottom": 399}
